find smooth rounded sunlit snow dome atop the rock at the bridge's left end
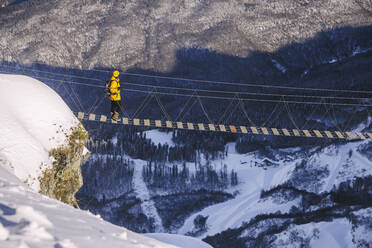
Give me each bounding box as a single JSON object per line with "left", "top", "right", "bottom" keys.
{"left": 0, "top": 74, "right": 78, "bottom": 190}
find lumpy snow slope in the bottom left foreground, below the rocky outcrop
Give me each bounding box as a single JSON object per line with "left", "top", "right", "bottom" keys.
{"left": 0, "top": 163, "right": 177, "bottom": 248}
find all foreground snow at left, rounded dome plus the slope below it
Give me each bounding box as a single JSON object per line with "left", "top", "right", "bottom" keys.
{"left": 0, "top": 74, "right": 210, "bottom": 248}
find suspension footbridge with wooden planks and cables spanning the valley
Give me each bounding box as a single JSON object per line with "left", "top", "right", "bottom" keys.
{"left": 0, "top": 65, "right": 372, "bottom": 140}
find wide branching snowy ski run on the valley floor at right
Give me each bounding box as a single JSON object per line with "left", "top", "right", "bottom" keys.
{"left": 178, "top": 141, "right": 372, "bottom": 240}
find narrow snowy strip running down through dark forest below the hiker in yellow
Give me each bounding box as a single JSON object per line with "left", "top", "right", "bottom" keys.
{"left": 133, "top": 160, "right": 163, "bottom": 232}
